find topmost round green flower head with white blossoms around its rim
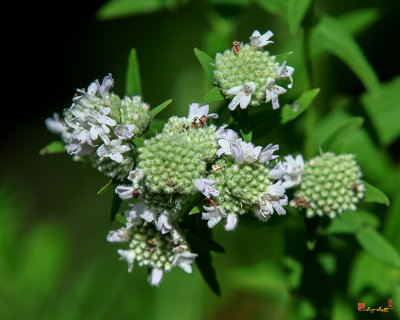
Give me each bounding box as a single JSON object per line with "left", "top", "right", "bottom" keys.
{"left": 214, "top": 30, "right": 294, "bottom": 110}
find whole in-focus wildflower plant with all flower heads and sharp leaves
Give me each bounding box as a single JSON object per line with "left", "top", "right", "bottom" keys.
{"left": 44, "top": 12, "right": 394, "bottom": 306}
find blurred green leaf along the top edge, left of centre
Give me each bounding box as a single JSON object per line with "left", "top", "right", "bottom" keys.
{"left": 96, "top": 0, "right": 189, "bottom": 20}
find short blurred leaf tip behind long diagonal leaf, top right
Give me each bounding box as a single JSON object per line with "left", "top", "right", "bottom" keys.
{"left": 337, "top": 8, "right": 380, "bottom": 36}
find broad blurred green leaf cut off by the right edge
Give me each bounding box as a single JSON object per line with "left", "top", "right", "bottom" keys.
{"left": 361, "top": 77, "right": 400, "bottom": 144}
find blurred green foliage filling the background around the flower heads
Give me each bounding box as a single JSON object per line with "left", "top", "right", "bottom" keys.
{"left": 4, "top": 0, "right": 400, "bottom": 320}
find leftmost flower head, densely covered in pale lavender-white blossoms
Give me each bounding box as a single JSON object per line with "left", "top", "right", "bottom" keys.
{"left": 46, "top": 75, "right": 150, "bottom": 179}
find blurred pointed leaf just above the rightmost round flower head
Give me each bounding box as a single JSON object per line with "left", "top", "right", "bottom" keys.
{"left": 319, "top": 117, "right": 364, "bottom": 152}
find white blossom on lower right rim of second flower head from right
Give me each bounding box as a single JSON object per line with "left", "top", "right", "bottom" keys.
{"left": 256, "top": 181, "right": 288, "bottom": 220}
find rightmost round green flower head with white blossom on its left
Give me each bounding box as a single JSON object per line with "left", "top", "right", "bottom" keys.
{"left": 284, "top": 152, "right": 364, "bottom": 218}
